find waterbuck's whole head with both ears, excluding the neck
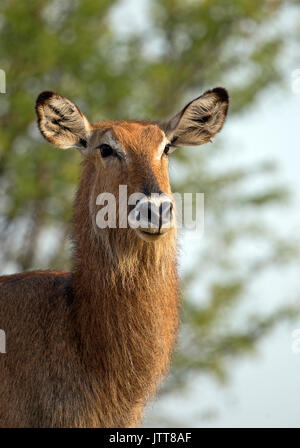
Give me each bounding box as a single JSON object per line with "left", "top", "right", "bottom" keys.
{"left": 36, "top": 88, "right": 228, "bottom": 241}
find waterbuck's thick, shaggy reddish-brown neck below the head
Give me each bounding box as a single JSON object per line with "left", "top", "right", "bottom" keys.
{"left": 73, "top": 159, "right": 178, "bottom": 426}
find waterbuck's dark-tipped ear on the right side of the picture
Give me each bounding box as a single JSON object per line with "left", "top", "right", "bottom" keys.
{"left": 163, "top": 87, "right": 229, "bottom": 146}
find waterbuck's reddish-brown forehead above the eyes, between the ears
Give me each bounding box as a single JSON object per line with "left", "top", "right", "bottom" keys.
{"left": 93, "top": 121, "right": 165, "bottom": 151}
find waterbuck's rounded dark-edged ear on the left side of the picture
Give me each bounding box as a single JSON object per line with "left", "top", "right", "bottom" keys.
{"left": 36, "top": 91, "right": 91, "bottom": 152}
